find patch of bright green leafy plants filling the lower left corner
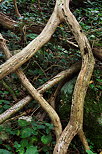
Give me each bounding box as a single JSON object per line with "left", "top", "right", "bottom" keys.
{"left": 0, "top": 119, "right": 54, "bottom": 154}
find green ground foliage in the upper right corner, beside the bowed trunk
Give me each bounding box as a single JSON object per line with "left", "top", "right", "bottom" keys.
{"left": 74, "top": 0, "right": 102, "bottom": 46}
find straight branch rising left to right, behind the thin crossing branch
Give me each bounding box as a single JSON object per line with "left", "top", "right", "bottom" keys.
{"left": 0, "top": 62, "right": 81, "bottom": 124}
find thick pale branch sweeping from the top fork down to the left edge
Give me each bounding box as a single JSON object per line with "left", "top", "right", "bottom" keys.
{"left": 0, "top": 6, "right": 60, "bottom": 79}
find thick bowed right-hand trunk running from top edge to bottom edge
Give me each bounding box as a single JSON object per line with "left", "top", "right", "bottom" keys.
{"left": 53, "top": 0, "right": 95, "bottom": 154}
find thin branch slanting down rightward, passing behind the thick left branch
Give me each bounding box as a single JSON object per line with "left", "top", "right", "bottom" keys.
{"left": 0, "top": 35, "right": 62, "bottom": 140}
